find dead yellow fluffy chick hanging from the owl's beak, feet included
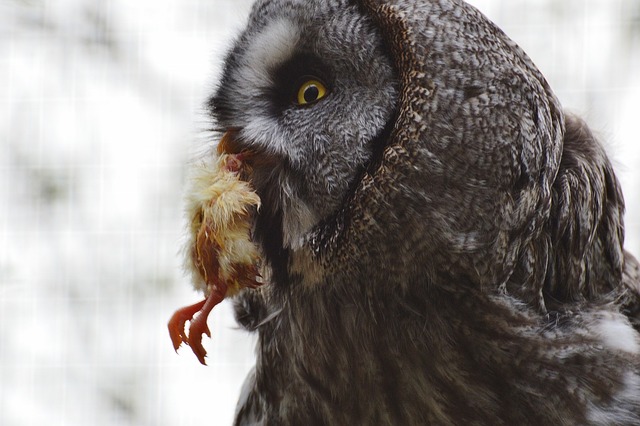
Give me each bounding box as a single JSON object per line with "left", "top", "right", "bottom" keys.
{"left": 168, "top": 132, "right": 260, "bottom": 364}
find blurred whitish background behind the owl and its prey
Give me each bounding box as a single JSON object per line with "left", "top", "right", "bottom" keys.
{"left": 0, "top": 0, "right": 640, "bottom": 426}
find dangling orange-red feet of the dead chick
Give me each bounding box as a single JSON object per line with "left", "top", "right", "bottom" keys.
{"left": 168, "top": 285, "right": 227, "bottom": 365}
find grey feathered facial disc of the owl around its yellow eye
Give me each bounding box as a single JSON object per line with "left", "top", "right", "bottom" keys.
{"left": 210, "top": 0, "right": 398, "bottom": 249}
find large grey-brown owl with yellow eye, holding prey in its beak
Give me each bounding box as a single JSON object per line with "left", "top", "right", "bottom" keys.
{"left": 185, "top": 0, "right": 640, "bottom": 425}
